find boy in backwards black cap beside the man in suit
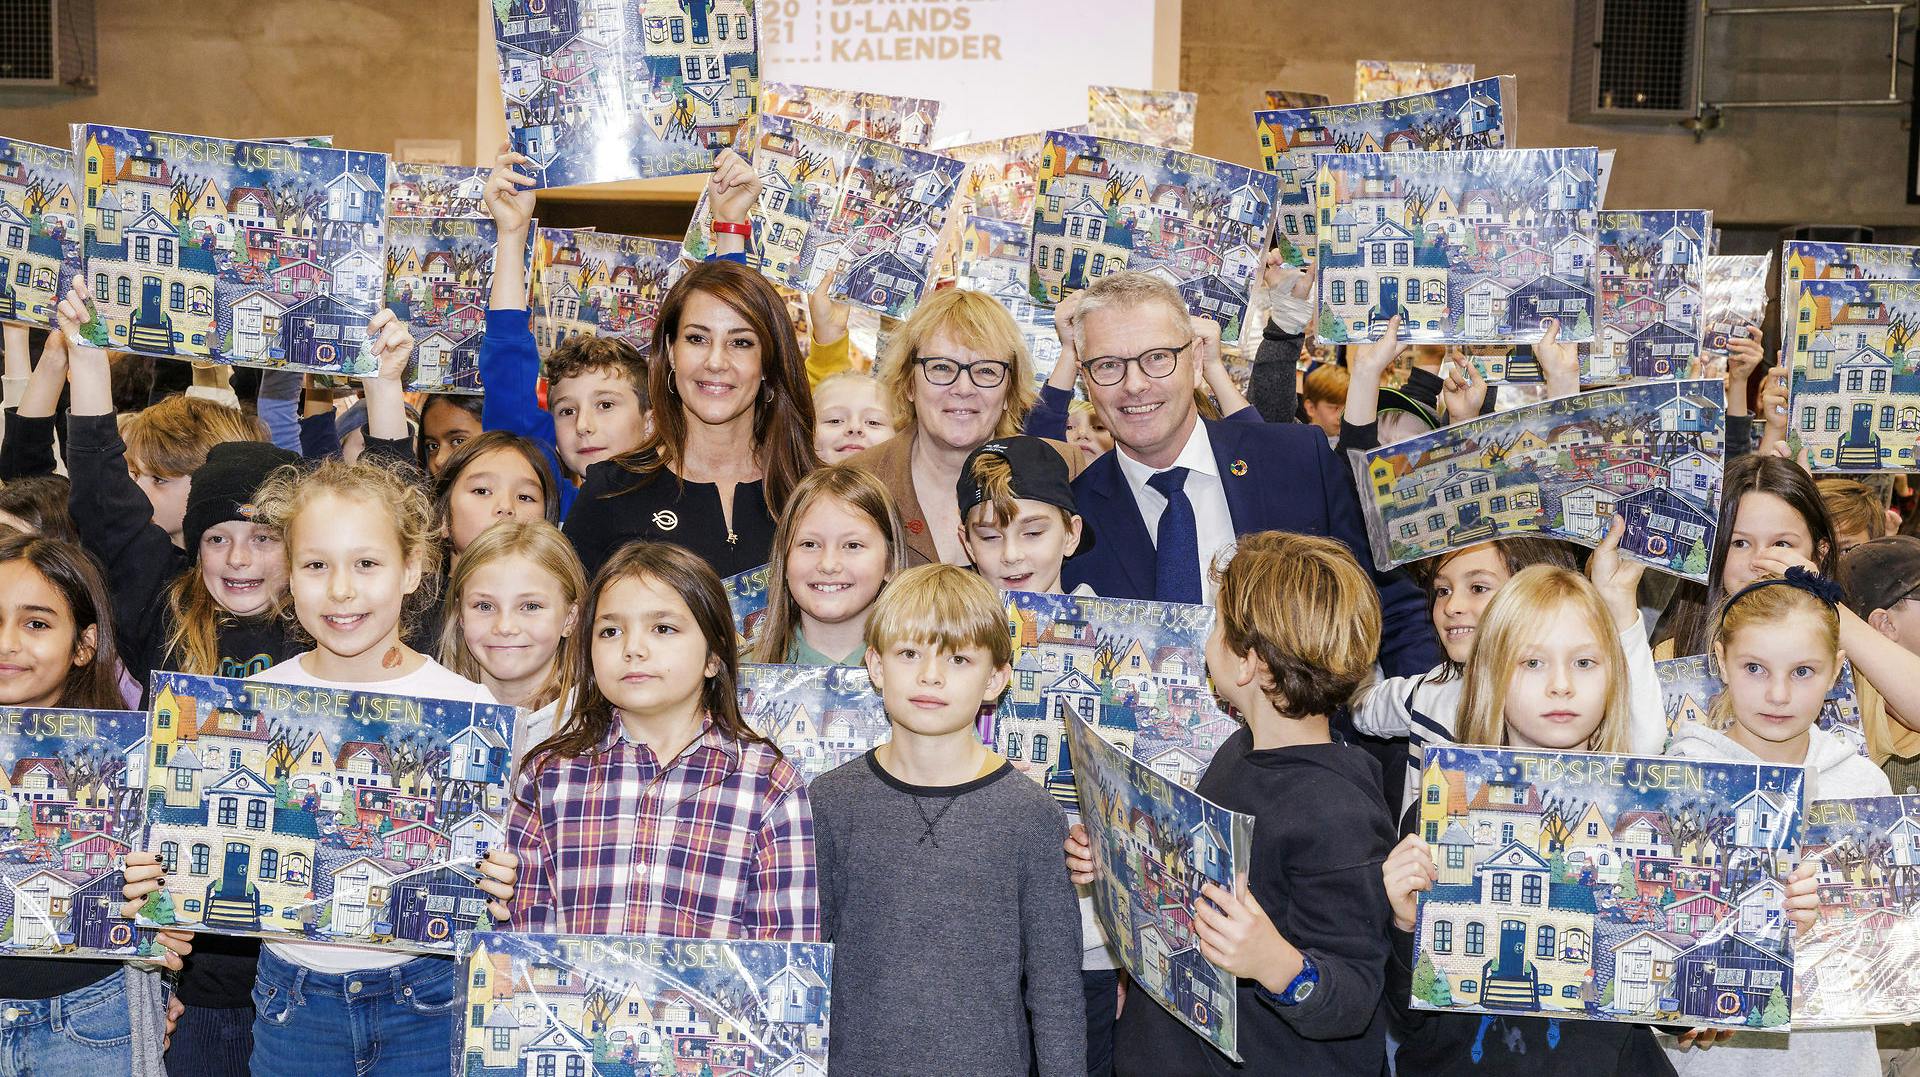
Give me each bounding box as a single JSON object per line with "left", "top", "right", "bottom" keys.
{"left": 956, "top": 436, "right": 1092, "bottom": 595}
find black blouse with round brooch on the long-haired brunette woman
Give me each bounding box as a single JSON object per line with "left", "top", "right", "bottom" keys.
{"left": 561, "top": 461, "right": 774, "bottom": 578}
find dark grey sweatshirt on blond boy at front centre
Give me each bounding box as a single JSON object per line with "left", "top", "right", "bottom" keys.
{"left": 806, "top": 753, "right": 1087, "bottom": 1077}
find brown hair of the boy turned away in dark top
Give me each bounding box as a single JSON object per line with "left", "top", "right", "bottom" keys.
{"left": 1213, "top": 532, "right": 1380, "bottom": 718}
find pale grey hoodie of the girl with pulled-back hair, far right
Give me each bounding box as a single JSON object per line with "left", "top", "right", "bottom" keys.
{"left": 1661, "top": 722, "right": 1893, "bottom": 1077}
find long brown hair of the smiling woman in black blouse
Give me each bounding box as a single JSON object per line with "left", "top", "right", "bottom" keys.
{"left": 618, "top": 261, "right": 820, "bottom": 516}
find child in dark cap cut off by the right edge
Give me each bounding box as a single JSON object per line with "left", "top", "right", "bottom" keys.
{"left": 1839, "top": 536, "right": 1920, "bottom": 793}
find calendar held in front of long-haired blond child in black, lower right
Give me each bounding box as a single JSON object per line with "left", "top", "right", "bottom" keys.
{"left": 1413, "top": 747, "right": 1803, "bottom": 1033}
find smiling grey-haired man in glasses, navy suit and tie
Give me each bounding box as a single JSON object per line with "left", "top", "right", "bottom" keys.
{"left": 1062, "top": 271, "right": 1440, "bottom": 676}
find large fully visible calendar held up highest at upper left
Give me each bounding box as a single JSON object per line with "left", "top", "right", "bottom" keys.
{"left": 73, "top": 123, "right": 388, "bottom": 374}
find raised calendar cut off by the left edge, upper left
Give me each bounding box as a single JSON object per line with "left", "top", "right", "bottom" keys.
{"left": 0, "top": 138, "right": 81, "bottom": 328}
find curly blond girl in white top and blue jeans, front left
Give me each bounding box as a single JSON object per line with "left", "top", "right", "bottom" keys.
{"left": 127, "top": 323, "right": 516, "bottom": 1077}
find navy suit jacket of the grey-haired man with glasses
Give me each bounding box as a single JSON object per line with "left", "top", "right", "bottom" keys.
{"left": 1062, "top": 419, "right": 1440, "bottom": 676}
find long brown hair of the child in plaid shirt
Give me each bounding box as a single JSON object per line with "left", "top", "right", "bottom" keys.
{"left": 526, "top": 541, "right": 778, "bottom": 774}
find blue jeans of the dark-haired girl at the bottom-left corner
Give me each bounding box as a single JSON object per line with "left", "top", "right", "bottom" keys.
{"left": 0, "top": 969, "right": 132, "bottom": 1077}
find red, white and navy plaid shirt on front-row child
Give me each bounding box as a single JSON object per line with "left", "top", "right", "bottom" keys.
{"left": 507, "top": 720, "right": 820, "bottom": 943}
